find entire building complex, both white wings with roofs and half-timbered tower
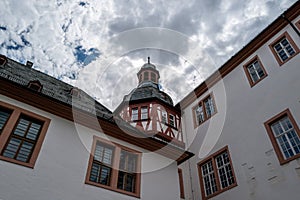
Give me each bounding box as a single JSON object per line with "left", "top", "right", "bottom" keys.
{"left": 0, "top": 2, "right": 300, "bottom": 200}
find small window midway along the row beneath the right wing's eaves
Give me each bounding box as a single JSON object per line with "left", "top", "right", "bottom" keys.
{"left": 244, "top": 56, "right": 267, "bottom": 87}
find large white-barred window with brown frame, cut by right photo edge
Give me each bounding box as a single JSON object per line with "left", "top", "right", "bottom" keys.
{"left": 265, "top": 109, "right": 300, "bottom": 164}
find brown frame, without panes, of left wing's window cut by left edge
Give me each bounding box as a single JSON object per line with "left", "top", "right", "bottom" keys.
{"left": 0, "top": 101, "right": 51, "bottom": 168}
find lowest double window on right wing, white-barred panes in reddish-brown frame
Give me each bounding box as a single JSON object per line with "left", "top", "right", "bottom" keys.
{"left": 198, "top": 147, "right": 237, "bottom": 199}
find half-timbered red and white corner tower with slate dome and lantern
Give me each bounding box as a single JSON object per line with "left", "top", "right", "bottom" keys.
{"left": 114, "top": 57, "right": 184, "bottom": 147}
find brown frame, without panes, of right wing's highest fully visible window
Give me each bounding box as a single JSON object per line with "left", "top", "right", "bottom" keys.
{"left": 269, "top": 32, "right": 300, "bottom": 66}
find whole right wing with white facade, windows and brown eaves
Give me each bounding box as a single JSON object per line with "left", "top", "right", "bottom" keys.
{"left": 179, "top": 2, "right": 300, "bottom": 200}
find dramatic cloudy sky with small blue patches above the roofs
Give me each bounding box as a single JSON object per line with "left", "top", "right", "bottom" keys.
{"left": 0, "top": 0, "right": 296, "bottom": 110}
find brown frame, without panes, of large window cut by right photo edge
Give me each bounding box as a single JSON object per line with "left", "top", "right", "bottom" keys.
{"left": 264, "top": 109, "right": 300, "bottom": 165}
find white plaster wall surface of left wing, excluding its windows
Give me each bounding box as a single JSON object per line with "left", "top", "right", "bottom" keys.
{"left": 0, "top": 95, "right": 179, "bottom": 200}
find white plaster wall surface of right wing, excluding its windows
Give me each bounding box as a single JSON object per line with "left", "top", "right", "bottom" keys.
{"left": 180, "top": 17, "right": 300, "bottom": 200}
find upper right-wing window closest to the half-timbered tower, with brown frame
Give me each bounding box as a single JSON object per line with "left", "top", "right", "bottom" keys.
{"left": 193, "top": 94, "right": 217, "bottom": 127}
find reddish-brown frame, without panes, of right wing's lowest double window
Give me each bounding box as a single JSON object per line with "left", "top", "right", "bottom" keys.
{"left": 197, "top": 146, "right": 237, "bottom": 200}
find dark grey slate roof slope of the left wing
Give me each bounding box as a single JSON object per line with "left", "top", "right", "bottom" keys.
{"left": 0, "top": 56, "right": 113, "bottom": 121}
